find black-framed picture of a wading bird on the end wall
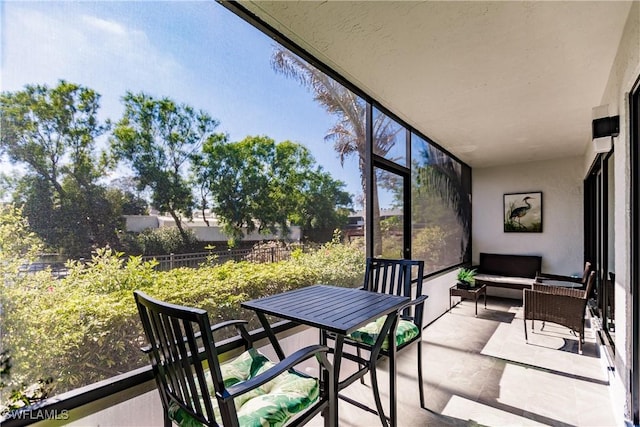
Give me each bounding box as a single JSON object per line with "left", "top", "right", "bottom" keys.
{"left": 503, "top": 191, "right": 542, "bottom": 233}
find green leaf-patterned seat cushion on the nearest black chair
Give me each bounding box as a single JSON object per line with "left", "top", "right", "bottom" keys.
{"left": 169, "top": 349, "right": 319, "bottom": 427}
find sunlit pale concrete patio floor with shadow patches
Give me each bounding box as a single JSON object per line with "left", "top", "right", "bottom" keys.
{"left": 312, "top": 297, "right": 622, "bottom": 427}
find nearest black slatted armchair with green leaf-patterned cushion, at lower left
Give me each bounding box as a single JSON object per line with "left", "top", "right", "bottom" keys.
{"left": 134, "top": 291, "right": 335, "bottom": 426}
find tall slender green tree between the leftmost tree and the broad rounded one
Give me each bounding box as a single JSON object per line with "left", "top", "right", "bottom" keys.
{"left": 111, "top": 92, "right": 225, "bottom": 242}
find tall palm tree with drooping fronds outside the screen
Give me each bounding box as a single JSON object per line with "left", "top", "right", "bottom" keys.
{"left": 271, "top": 48, "right": 400, "bottom": 255}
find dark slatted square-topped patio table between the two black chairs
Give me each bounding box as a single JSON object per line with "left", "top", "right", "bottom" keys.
{"left": 241, "top": 285, "right": 409, "bottom": 426}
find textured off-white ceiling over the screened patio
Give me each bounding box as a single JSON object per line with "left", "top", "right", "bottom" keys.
{"left": 235, "top": 1, "right": 631, "bottom": 167}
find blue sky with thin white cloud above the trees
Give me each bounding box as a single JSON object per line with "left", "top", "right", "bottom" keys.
{"left": 0, "top": 1, "right": 376, "bottom": 208}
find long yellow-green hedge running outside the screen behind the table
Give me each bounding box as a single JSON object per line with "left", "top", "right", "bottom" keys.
{"left": 3, "top": 242, "right": 364, "bottom": 400}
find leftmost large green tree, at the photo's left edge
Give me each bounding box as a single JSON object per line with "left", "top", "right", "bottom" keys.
{"left": 0, "top": 80, "right": 118, "bottom": 255}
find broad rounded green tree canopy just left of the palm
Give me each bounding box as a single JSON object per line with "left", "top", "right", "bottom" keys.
{"left": 194, "top": 136, "right": 351, "bottom": 245}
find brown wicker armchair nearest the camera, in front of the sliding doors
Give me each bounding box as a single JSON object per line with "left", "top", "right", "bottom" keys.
{"left": 523, "top": 271, "right": 596, "bottom": 354}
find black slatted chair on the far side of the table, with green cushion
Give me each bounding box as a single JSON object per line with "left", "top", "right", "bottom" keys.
{"left": 332, "top": 258, "right": 428, "bottom": 425}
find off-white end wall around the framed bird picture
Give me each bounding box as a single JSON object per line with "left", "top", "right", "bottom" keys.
{"left": 472, "top": 157, "right": 584, "bottom": 275}
